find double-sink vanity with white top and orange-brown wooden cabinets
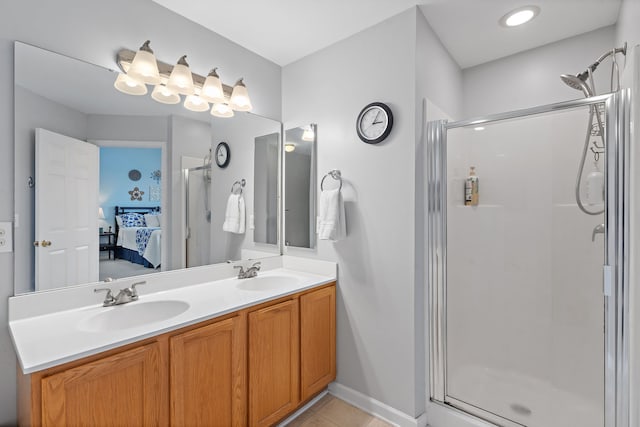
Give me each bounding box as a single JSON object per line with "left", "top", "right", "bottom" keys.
{"left": 9, "top": 256, "right": 336, "bottom": 426}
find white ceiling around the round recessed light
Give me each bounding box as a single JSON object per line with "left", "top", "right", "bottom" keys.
{"left": 153, "top": 0, "right": 621, "bottom": 68}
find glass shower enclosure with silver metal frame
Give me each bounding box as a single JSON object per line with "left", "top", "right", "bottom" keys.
{"left": 426, "top": 92, "right": 629, "bottom": 427}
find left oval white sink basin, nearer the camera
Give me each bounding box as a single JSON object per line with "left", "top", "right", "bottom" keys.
{"left": 78, "top": 300, "right": 189, "bottom": 332}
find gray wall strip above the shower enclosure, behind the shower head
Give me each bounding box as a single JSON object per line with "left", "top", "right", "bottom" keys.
{"left": 463, "top": 27, "right": 615, "bottom": 118}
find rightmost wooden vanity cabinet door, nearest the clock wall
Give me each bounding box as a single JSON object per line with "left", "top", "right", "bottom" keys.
{"left": 300, "top": 286, "right": 336, "bottom": 400}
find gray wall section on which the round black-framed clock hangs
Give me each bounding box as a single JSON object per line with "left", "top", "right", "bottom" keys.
{"left": 283, "top": 8, "right": 460, "bottom": 416}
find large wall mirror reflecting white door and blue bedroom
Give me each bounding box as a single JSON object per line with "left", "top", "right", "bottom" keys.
{"left": 15, "top": 42, "right": 282, "bottom": 294}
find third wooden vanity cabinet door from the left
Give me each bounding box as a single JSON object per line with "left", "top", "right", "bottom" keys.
{"left": 249, "top": 299, "right": 300, "bottom": 426}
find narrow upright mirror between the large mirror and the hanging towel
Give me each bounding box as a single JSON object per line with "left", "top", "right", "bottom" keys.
{"left": 284, "top": 124, "right": 318, "bottom": 248}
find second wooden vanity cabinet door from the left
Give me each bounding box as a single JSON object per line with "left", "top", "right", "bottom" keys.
{"left": 170, "top": 315, "right": 247, "bottom": 427}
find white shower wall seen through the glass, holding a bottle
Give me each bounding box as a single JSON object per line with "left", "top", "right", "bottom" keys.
{"left": 447, "top": 108, "right": 604, "bottom": 427}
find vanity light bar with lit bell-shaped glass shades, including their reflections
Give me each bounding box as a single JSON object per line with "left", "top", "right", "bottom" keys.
{"left": 114, "top": 41, "right": 252, "bottom": 117}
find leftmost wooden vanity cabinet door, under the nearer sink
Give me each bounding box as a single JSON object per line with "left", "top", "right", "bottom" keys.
{"left": 41, "top": 342, "right": 168, "bottom": 427}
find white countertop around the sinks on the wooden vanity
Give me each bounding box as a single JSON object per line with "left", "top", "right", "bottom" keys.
{"left": 9, "top": 260, "right": 336, "bottom": 374}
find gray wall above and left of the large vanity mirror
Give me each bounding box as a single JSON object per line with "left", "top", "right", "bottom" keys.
{"left": 0, "top": 0, "right": 281, "bottom": 425}
